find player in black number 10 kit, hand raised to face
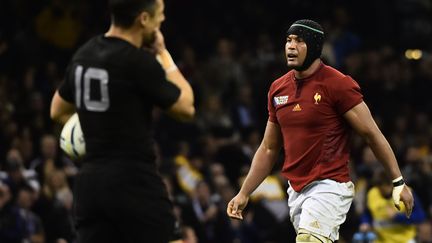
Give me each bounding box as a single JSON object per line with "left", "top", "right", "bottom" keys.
{"left": 51, "top": 0, "right": 195, "bottom": 243}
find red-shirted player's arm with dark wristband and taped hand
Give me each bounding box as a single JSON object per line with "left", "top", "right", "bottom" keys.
{"left": 344, "top": 102, "right": 414, "bottom": 217}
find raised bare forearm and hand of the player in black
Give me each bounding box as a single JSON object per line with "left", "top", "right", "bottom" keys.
{"left": 153, "top": 30, "right": 195, "bottom": 120}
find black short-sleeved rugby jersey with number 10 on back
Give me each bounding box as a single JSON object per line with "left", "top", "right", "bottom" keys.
{"left": 59, "top": 35, "right": 180, "bottom": 162}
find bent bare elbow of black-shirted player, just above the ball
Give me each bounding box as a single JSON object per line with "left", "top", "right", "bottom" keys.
{"left": 50, "top": 91, "right": 75, "bottom": 124}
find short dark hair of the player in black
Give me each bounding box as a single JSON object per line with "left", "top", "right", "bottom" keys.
{"left": 108, "top": 0, "right": 156, "bottom": 28}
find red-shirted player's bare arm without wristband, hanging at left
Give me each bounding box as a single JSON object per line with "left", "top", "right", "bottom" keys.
{"left": 227, "top": 121, "right": 282, "bottom": 219}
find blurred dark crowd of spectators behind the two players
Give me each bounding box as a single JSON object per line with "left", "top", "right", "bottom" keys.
{"left": 0, "top": 0, "right": 432, "bottom": 243}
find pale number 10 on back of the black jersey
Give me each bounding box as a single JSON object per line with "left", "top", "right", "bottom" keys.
{"left": 75, "top": 65, "right": 109, "bottom": 112}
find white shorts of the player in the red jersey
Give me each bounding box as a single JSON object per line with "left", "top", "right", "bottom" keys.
{"left": 287, "top": 179, "right": 354, "bottom": 241}
